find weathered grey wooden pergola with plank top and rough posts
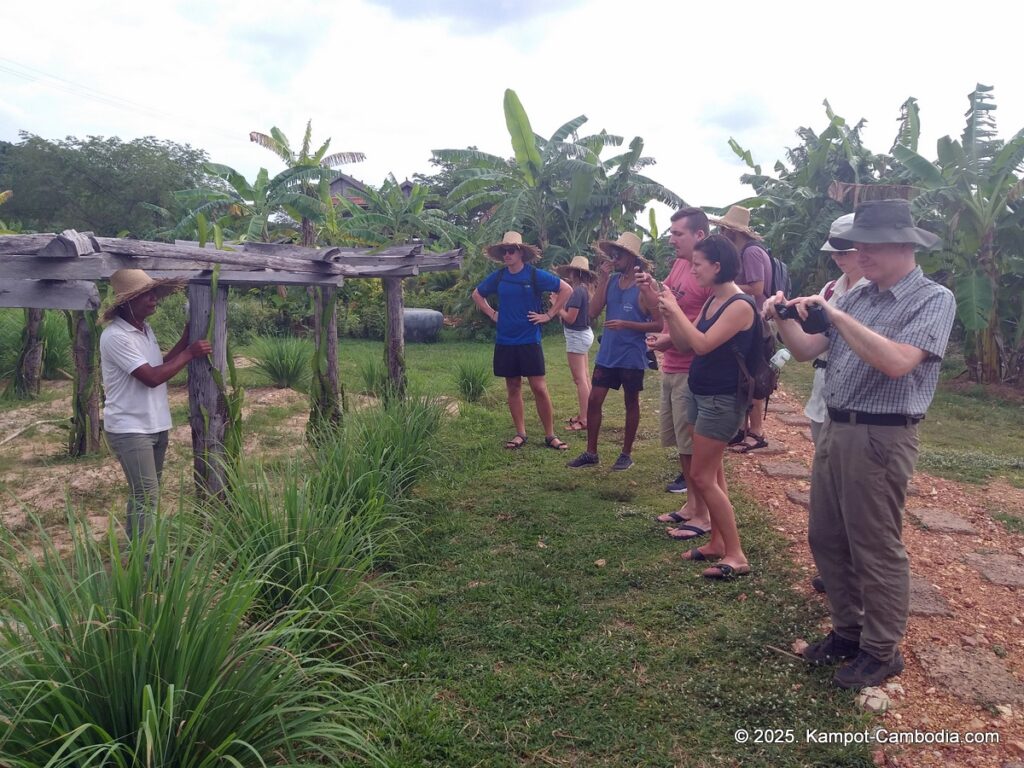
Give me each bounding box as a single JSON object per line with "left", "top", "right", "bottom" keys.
{"left": 0, "top": 230, "right": 462, "bottom": 495}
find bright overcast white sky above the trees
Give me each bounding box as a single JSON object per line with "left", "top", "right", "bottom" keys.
{"left": 0, "top": 0, "right": 1024, "bottom": 222}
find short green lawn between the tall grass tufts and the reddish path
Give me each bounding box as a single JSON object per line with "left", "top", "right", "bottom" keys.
{"left": 372, "top": 338, "right": 871, "bottom": 767}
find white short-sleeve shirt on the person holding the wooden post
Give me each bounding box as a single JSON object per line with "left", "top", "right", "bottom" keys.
{"left": 99, "top": 317, "right": 171, "bottom": 434}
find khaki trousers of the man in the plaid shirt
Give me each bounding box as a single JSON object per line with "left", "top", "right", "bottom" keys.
{"left": 807, "top": 418, "right": 918, "bottom": 662}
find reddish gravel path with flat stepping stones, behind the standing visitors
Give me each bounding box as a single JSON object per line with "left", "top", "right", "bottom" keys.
{"left": 728, "top": 393, "right": 1024, "bottom": 768}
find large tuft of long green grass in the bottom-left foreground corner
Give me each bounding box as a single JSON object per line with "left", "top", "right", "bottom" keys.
{"left": 0, "top": 514, "right": 383, "bottom": 768}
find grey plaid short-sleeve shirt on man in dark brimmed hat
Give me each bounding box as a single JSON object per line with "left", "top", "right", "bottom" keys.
{"left": 824, "top": 266, "right": 956, "bottom": 418}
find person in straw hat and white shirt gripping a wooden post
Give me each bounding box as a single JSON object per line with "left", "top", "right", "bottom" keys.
{"left": 99, "top": 269, "right": 211, "bottom": 541}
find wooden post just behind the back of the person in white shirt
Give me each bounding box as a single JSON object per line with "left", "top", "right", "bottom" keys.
{"left": 68, "top": 310, "right": 99, "bottom": 456}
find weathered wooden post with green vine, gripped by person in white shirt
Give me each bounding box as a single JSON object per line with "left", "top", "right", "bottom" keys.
{"left": 188, "top": 284, "right": 228, "bottom": 499}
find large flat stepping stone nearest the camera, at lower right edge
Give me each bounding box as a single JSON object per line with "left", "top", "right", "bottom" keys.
{"left": 918, "top": 645, "right": 1024, "bottom": 708}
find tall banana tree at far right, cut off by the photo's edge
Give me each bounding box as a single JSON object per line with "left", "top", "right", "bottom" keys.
{"left": 893, "top": 84, "right": 1024, "bottom": 382}
